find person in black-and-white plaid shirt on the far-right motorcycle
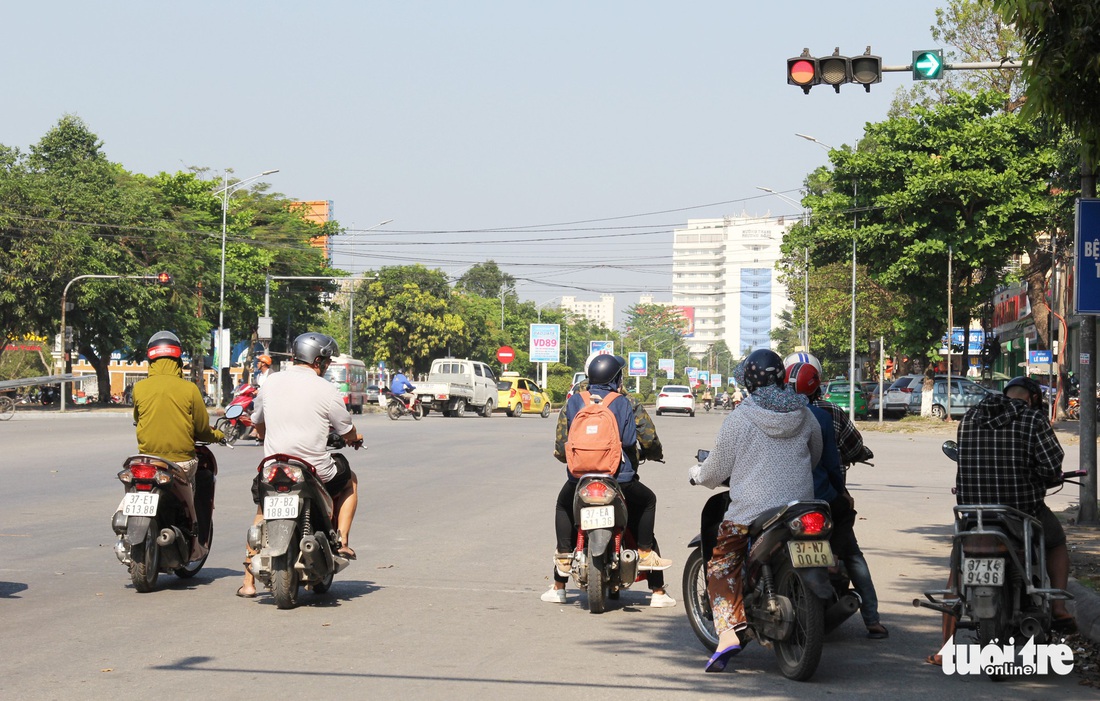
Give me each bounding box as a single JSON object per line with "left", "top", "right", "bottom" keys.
{"left": 956, "top": 377, "right": 1073, "bottom": 628}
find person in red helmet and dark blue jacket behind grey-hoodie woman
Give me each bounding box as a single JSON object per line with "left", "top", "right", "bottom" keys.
{"left": 787, "top": 362, "right": 890, "bottom": 640}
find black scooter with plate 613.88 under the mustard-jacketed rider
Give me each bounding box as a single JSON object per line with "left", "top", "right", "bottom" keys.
{"left": 111, "top": 443, "right": 218, "bottom": 593}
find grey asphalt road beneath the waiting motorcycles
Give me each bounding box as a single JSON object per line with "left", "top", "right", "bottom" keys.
{"left": 0, "top": 412, "right": 1088, "bottom": 701}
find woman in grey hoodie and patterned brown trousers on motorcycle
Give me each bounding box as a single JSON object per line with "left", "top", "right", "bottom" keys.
{"left": 691, "top": 350, "right": 822, "bottom": 672}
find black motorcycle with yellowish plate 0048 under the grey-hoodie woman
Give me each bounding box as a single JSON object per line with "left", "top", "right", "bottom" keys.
{"left": 683, "top": 450, "right": 859, "bottom": 681}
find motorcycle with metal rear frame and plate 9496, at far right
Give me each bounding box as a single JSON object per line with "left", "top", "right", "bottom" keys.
{"left": 913, "top": 440, "right": 1086, "bottom": 660}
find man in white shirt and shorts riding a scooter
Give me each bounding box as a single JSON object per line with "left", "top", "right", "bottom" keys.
{"left": 237, "top": 332, "right": 363, "bottom": 599}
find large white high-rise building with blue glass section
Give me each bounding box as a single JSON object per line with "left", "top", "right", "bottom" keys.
{"left": 672, "top": 213, "right": 795, "bottom": 355}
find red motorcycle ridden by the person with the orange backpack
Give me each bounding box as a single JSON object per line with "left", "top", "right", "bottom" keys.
{"left": 570, "top": 474, "right": 649, "bottom": 613}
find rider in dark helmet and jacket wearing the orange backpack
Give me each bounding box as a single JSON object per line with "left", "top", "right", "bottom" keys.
{"left": 541, "top": 353, "right": 677, "bottom": 607}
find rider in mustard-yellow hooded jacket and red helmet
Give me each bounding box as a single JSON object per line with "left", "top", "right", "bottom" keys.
{"left": 133, "top": 331, "right": 226, "bottom": 551}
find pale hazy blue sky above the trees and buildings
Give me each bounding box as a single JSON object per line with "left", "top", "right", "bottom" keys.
{"left": 0, "top": 0, "right": 937, "bottom": 330}
